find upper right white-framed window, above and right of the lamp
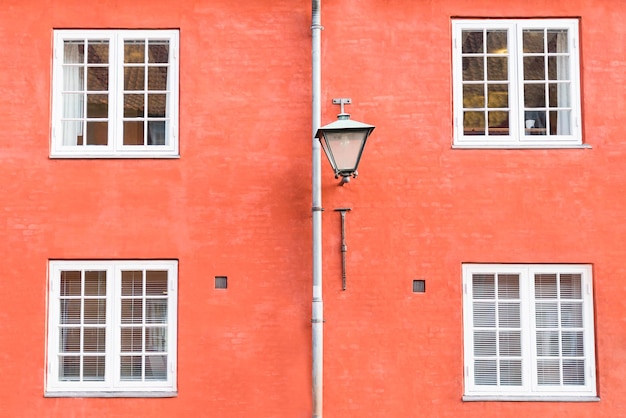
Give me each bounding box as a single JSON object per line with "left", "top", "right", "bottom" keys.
{"left": 452, "top": 19, "right": 582, "bottom": 148}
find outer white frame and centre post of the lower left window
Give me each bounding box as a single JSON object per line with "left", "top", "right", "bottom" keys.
{"left": 45, "top": 260, "right": 178, "bottom": 397}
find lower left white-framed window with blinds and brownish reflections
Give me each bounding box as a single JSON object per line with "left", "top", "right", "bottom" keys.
{"left": 46, "top": 261, "right": 178, "bottom": 396}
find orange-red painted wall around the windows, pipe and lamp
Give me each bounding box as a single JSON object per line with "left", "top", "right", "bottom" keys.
{"left": 0, "top": 0, "right": 626, "bottom": 418}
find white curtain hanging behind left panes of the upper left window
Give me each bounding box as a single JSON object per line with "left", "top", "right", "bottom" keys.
{"left": 62, "top": 42, "right": 84, "bottom": 145}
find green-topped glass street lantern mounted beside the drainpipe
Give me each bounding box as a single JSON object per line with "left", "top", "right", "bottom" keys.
{"left": 315, "top": 98, "right": 374, "bottom": 186}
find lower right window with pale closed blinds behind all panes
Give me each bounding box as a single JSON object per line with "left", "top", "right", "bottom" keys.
{"left": 463, "top": 264, "right": 596, "bottom": 400}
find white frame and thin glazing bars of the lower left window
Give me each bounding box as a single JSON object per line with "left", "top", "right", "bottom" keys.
{"left": 46, "top": 260, "right": 178, "bottom": 396}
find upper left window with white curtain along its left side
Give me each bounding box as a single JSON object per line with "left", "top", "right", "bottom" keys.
{"left": 50, "top": 30, "right": 178, "bottom": 158}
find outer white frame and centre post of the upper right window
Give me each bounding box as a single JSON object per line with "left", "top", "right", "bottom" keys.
{"left": 452, "top": 19, "right": 588, "bottom": 148}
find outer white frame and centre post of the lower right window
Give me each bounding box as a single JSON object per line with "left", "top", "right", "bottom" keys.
{"left": 462, "top": 264, "right": 598, "bottom": 401}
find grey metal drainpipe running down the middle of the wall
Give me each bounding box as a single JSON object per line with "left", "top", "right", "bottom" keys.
{"left": 311, "top": 0, "right": 324, "bottom": 418}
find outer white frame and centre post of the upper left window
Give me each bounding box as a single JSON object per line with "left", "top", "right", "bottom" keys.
{"left": 50, "top": 30, "right": 179, "bottom": 158}
